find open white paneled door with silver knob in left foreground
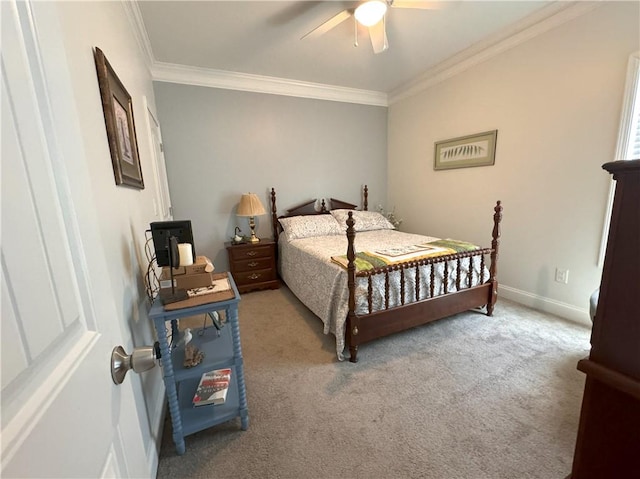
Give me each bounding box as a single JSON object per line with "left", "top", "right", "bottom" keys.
{"left": 0, "top": 0, "right": 150, "bottom": 478}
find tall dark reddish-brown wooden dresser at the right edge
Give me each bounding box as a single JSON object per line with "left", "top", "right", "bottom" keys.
{"left": 570, "top": 160, "right": 640, "bottom": 479}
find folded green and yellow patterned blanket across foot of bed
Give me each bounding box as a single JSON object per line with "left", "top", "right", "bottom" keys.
{"left": 331, "top": 239, "right": 479, "bottom": 271}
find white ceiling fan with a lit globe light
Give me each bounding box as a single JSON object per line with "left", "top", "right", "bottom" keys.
{"left": 302, "top": 0, "right": 446, "bottom": 53}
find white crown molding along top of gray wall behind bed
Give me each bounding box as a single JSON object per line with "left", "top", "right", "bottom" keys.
{"left": 151, "top": 62, "right": 388, "bottom": 106}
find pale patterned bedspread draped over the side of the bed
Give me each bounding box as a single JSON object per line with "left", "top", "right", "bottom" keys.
{"left": 278, "top": 230, "right": 489, "bottom": 360}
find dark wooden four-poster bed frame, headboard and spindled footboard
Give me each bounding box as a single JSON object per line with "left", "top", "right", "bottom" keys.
{"left": 271, "top": 185, "right": 502, "bottom": 363}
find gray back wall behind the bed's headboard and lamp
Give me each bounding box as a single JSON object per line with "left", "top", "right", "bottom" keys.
{"left": 154, "top": 82, "right": 387, "bottom": 271}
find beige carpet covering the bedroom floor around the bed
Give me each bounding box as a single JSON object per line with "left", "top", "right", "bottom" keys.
{"left": 158, "top": 288, "right": 590, "bottom": 479}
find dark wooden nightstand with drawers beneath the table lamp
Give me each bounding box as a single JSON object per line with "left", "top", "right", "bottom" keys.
{"left": 224, "top": 239, "right": 280, "bottom": 293}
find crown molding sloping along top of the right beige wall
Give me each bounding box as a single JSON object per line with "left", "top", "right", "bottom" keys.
{"left": 388, "top": 1, "right": 605, "bottom": 105}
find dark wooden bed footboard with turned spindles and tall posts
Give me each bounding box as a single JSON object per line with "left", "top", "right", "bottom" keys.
{"left": 345, "top": 201, "right": 502, "bottom": 362}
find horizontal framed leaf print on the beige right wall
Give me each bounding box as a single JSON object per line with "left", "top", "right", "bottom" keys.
{"left": 433, "top": 130, "right": 498, "bottom": 170}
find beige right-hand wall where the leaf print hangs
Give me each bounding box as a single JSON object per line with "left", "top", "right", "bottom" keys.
{"left": 389, "top": 2, "right": 640, "bottom": 323}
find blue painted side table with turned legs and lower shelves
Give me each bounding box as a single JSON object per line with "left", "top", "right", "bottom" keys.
{"left": 149, "top": 273, "right": 249, "bottom": 454}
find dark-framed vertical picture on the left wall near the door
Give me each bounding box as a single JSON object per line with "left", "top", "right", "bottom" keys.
{"left": 94, "top": 47, "right": 144, "bottom": 189}
